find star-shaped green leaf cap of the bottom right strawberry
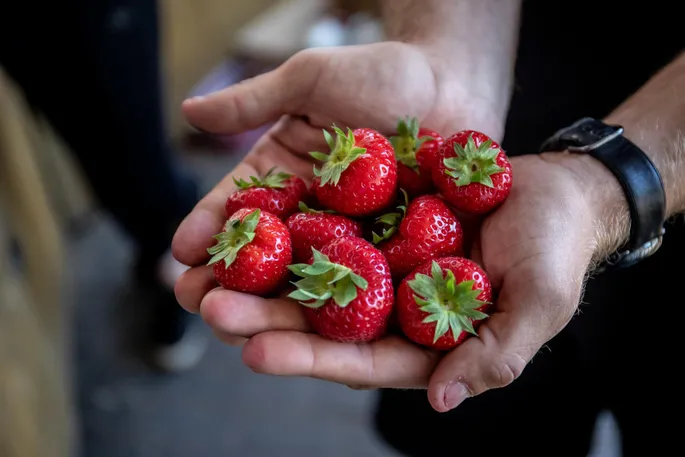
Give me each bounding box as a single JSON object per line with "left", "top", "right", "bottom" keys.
{"left": 408, "top": 261, "right": 489, "bottom": 342}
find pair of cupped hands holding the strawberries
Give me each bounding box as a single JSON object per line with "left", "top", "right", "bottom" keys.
{"left": 173, "top": 42, "right": 596, "bottom": 412}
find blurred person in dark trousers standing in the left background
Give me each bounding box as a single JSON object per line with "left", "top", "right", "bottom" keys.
{"left": 0, "top": 0, "right": 204, "bottom": 371}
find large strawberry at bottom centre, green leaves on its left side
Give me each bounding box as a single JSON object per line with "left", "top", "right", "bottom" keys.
{"left": 288, "top": 236, "right": 394, "bottom": 343}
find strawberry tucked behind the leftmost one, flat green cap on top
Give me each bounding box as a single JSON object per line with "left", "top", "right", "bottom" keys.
{"left": 226, "top": 167, "right": 309, "bottom": 219}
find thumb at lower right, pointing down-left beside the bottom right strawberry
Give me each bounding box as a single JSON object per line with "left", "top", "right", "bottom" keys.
{"left": 428, "top": 281, "right": 575, "bottom": 412}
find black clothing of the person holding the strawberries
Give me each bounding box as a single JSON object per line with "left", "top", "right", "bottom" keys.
{"left": 376, "top": 0, "right": 685, "bottom": 457}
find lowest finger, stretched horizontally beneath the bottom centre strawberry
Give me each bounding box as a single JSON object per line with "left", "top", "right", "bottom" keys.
{"left": 243, "top": 331, "right": 438, "bottom": 388}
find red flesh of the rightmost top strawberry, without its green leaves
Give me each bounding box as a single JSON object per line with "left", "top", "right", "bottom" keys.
{"left": 433, "top": 130, "right": 513, "bottom": 214}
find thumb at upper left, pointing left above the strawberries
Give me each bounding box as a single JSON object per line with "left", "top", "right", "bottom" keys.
{"left": 181, "top": 64, "right": 311, "bottom": 135}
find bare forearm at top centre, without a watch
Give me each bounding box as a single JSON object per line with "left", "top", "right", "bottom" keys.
{"left": 382, "top": 0, "right": 521, "bottom": 128}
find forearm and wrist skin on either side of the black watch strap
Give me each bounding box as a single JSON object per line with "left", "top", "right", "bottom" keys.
{"left": 564, "top": 53, "right": 685, "bottom": 258}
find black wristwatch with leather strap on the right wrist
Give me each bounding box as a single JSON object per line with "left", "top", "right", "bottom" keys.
{"left": 540, "top": 117, "right": 666, "bottom": 271}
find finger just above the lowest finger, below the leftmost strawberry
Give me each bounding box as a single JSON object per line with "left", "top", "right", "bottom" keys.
{"left": 200, "top": 288, "right": 310, "bottom": 338}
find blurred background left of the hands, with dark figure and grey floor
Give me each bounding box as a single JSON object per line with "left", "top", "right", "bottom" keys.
{"left": 0, "top": 0, "right": 617, "bottom": 457}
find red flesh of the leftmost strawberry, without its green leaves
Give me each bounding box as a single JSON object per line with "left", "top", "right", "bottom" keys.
{"left": 212, "top": 208, "right": 292, "bottom": 296}
